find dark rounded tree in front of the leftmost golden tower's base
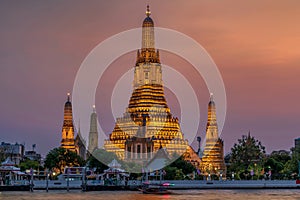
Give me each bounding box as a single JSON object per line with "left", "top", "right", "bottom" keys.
{"left": 45, "top": 147, "right": 85, "bottom": 173}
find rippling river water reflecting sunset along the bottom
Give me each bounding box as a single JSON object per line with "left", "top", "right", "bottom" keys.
{"left": 0, "top": 189, "right": 300, "bottom": 200}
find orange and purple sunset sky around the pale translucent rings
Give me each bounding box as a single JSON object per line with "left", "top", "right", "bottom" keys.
{"left": 0, "top": 0, "right": 300, "bottom": 155}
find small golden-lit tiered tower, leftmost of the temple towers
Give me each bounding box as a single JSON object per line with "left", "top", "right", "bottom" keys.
{"left": 61, "top": 93, "right": 75, "bottom": 151}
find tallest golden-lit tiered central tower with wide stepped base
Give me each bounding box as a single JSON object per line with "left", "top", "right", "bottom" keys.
{"left": 104, "top": 6, "right": 189, "bottom": 162}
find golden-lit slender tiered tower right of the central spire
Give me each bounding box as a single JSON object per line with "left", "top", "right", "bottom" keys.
{"left": 200, "top": 94, "right": 226, "bottom": 178}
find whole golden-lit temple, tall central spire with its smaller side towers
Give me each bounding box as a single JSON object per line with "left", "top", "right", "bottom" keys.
{"left": 61, "top": 6, "right": 226, "bottom": 175}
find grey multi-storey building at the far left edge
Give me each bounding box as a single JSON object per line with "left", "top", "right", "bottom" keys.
{"left": 0, "top": 142, "right": 25, "bottom": 165}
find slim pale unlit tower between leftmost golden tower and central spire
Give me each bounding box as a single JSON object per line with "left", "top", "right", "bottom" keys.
{"left": 88, "top": 105, "right": 98, "bottom": 154}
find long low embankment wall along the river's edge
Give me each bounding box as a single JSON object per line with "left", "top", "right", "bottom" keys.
{"left": 0, "top": 180, "right": 300, "bottom": 191}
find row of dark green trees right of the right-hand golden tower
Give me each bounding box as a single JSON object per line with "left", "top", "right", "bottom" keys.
{"left": 225, "top": 135, "right": 300, "bottom": 180}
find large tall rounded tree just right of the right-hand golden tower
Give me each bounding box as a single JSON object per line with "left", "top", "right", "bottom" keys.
{"left": 228, "top": 133, "right": 266, "bottom": 179}
